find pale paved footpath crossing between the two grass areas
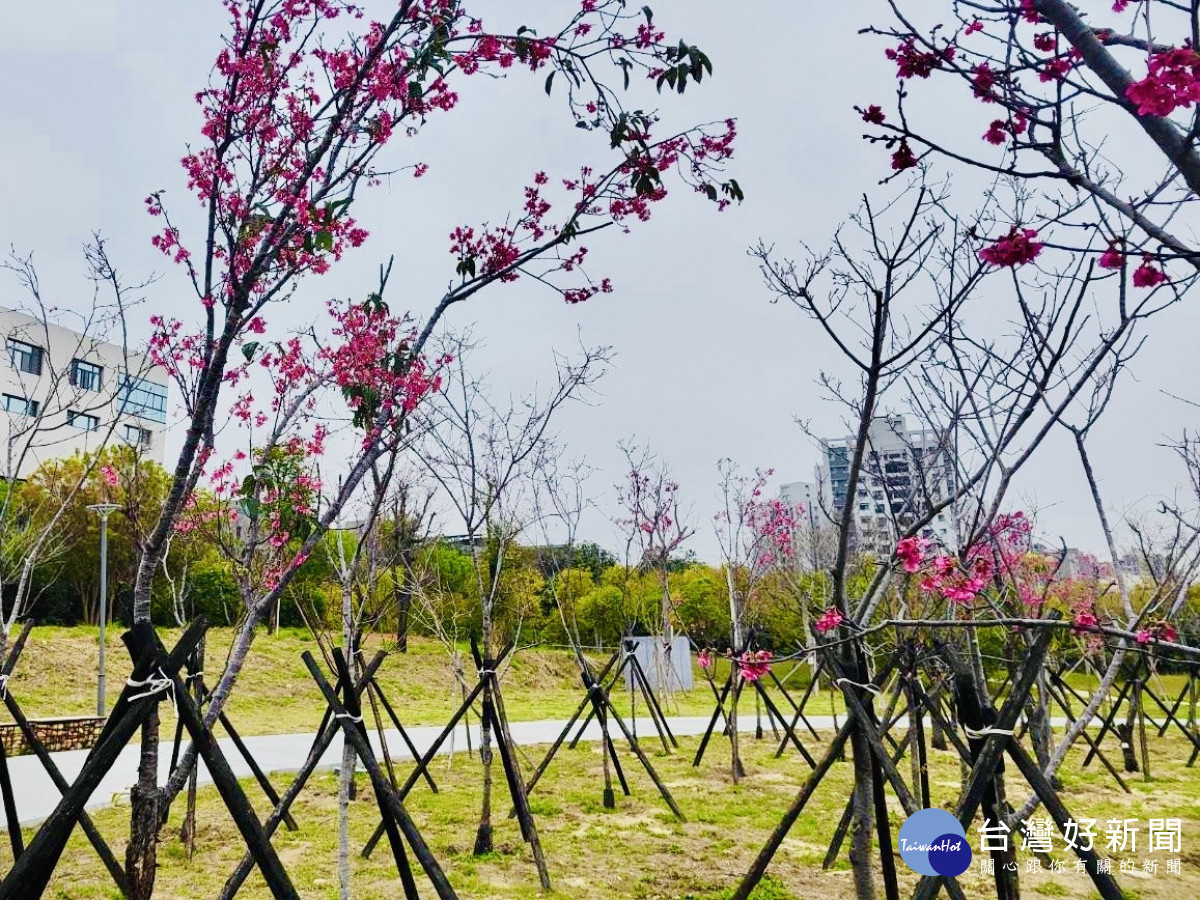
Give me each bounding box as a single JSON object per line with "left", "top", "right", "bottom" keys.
{"left": 7, "top": 713, "right": 840, "bottom": 830}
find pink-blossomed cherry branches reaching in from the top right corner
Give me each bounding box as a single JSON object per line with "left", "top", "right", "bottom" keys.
{"left": 858, "top": 0, "right": 1200, "bottom": 274}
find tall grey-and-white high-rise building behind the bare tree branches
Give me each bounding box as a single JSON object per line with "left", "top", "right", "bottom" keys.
{"left": 817, "top": 415, "right": 958, "bottom": 556}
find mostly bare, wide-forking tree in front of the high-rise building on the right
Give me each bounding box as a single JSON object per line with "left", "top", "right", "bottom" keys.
{"left": 734, "top": 175, "right": 1188, "bottom": 900}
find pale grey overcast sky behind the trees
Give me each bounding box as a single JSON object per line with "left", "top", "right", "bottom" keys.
{"left": 0, "top": 0, "right": 1200, "bottom": 558}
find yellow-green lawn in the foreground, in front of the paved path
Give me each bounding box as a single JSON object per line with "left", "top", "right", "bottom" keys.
{"left": 21, "top": 724, "right": 1200, "bottom": 900}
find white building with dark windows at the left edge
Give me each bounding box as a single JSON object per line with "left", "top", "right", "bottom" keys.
{"left": 0, "top": 307, "right": 167, "bottom": 479}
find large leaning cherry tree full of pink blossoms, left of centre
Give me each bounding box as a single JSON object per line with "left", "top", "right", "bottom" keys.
{"left": 127, "top": 0, "right": 742, "bottom": 898}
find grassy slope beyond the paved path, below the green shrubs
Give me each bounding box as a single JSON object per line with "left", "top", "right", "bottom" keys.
{"left": 0, "top": 626, "right": 841, "bottom": 734}
